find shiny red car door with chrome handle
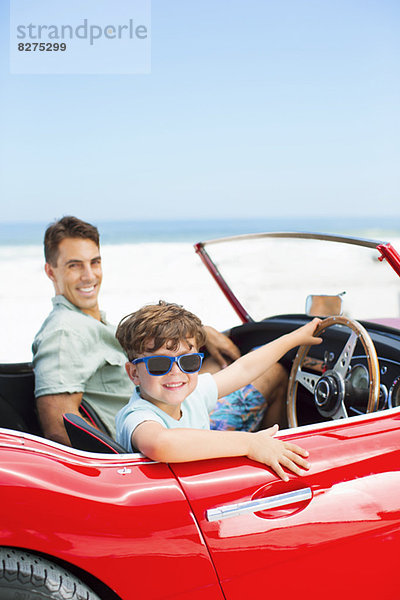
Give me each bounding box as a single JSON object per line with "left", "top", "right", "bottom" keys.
{"left": 172, "top": 412, "right": 400, "bottom": 600}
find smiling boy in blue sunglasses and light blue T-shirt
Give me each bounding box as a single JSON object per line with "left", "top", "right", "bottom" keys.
{"left": 116, "top": 301, "right": 322, "bottom": 481}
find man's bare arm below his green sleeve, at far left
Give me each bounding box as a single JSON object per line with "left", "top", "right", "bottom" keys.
{"left": 36, "top": 392, "right": 85, "bottom": 446}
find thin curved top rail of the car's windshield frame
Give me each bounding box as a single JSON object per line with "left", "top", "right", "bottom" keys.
{"left": 200, "top": 231, "right": 388, "bottom": 249}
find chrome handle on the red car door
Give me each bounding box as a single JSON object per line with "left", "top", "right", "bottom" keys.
{"left": 206, "top": 488, "right": 312, "bottom": 522}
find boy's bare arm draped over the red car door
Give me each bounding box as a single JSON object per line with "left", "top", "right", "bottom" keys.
{"left": 132, "top": 421, "right": 309, "bottom": 481}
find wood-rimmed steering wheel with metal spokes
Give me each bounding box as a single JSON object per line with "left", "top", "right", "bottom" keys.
{"left": 286, "top": 317, "right": 380, "bottom": 427}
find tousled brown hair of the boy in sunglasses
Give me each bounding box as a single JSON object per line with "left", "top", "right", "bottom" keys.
{"left": 115, "top": 300, "right": 206, "bottom": 360}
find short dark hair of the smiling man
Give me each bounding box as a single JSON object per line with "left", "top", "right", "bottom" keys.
{"left": 44, "top": 216, "right": 100, "bottom": 267}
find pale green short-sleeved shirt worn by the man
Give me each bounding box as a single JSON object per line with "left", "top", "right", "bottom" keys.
{"left": 32, "top": 296, "right": 134, "bottom": 437}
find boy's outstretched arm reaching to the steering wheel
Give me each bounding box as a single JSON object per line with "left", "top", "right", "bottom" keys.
{"left": 213, "top": 318, "right": 322, "bottom": 398}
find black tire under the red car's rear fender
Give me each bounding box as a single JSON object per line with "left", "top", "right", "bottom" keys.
{"left": 0, "top": 548, "right": 100, "bottom": 600}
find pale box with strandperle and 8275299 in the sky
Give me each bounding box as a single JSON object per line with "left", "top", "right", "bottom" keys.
{"left": 10, "top": 0, "right": 151, "bottom": 75}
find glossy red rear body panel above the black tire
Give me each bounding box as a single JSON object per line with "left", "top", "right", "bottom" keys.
{"left": 0, "top": 434, "right": 223, "bottom": 600}
